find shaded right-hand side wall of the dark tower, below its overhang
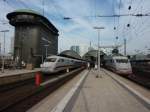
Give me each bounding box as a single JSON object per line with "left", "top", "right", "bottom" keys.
{"left": 36, "top": 25, "right": 58, "bottom": 66}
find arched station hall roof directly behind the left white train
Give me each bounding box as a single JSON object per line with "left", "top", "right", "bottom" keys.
{"left": 59, "top": 50, "right": 81, "bottom": 59}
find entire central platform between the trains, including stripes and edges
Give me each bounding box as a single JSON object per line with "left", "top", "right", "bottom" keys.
{"left": 29, "top": 69, "right": 150, "bottom": 112}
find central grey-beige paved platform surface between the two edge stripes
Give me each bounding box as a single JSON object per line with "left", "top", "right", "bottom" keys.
{"left": 72, "top": 70, "right": 149, "bottom": 112}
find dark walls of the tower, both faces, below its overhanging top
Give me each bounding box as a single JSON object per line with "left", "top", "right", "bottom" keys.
{"left": 14, "top": 24, "right": 58, "bottom": 67}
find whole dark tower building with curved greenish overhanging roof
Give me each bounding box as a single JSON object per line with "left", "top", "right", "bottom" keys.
{"left": 7, "top": 9, "right": 58, "bottom": 67}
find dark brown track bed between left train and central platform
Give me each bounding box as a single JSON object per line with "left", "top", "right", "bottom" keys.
{"left": 0, "top": 68, "right": 83, "bottom": 112}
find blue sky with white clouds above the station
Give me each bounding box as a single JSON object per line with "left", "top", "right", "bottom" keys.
{"left": 0, "top": 0, "right": 150, "bottom": 55}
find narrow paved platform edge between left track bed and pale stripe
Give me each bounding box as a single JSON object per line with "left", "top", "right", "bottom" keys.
{"left": 27, "top": 70, "right": 88, "bottom": 112}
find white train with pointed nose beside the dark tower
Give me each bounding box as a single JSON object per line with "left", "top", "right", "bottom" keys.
{"left": 41, "top": 55, "right": 85, "bottom": 73}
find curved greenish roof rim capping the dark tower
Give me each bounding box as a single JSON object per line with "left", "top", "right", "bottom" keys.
{"left": 7, "top": 9, "right": 58, "bottom": 33}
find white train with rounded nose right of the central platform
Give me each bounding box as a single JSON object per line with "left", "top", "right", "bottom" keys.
{"left": 104, "top": 55, "right": 132, "bottom": 76}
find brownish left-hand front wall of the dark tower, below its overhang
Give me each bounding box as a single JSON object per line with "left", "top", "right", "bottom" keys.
{"left": 14, "top": 25, "right": 38, "bottom": 63}
